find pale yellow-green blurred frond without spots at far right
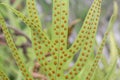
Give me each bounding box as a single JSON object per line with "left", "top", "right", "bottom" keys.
{"left": 103, "top": 32, "right": 118, "bottom": 80}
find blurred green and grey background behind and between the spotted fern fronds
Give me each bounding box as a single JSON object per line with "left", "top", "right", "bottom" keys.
{"left": 0, "top": 0, "right": 120, "bottom": 80}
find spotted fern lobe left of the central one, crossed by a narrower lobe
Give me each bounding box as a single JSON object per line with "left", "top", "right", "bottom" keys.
{"left": 26, "top": 0, "right": 49, "bottom": 73}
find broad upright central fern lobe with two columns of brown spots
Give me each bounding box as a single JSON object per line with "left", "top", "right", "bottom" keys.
{"left": 52, "top": 0, "right": 69, "bottom": 80}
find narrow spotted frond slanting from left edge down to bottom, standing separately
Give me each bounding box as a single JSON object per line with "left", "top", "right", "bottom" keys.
{"left": 0, "top": 14, "right": 33, "bottom": 80}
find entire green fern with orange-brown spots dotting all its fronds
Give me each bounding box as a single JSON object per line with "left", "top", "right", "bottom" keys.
{"left": 0, "top": 0, "right": 117, "bottom": 80}
